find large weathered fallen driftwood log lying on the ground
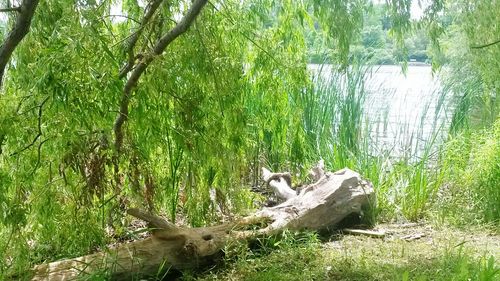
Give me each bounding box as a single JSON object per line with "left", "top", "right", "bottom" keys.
{"left": 32, "top": 163, "right": 374, "bottom": 280}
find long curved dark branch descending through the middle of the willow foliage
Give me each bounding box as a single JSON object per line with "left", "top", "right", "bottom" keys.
{"left": 113, "top": 0, "right": 207, "bottom": 151}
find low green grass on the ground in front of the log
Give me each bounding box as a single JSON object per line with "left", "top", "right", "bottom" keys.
{"left": 189, "top": 225, "right": 500, "bottom": 281}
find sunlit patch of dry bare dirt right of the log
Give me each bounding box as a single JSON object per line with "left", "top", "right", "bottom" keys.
{"left": 323, "top": 223, "right": 500, "bottom": 263}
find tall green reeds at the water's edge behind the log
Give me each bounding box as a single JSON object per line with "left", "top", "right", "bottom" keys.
{"left": 295, "top": 65, "right": 458, "bottom": 220}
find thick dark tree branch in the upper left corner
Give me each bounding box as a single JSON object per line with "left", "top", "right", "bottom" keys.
{"left": 0, "top": 0, "right": 39, "bottom": 87}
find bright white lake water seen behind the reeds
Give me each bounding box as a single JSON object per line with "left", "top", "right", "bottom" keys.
{"left": 309, "top": 65, "right": 449, "bottom": 157}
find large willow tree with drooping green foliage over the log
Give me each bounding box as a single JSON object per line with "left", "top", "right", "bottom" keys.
{"left": 0, "top": 0, "right": 448, "bottom": 278}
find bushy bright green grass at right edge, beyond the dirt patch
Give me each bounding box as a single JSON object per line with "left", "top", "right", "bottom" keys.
{"left": 437, "top": 117, "right": 500, "bottom": 226}
